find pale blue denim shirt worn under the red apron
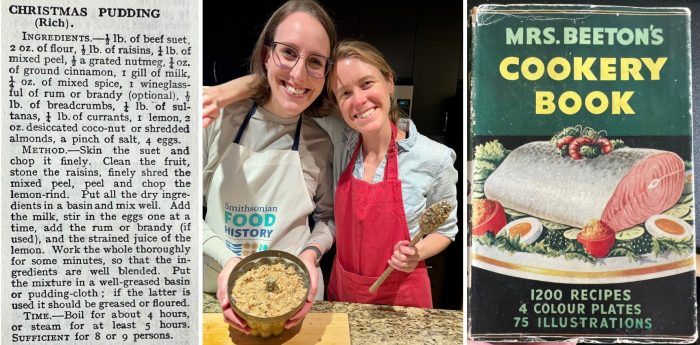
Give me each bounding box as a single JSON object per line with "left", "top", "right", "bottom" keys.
{"left": 315, "top": 116, "right": 459, "bottom": 241}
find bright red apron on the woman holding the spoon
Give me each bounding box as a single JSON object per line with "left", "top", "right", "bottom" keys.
{"left": 328, "top": 124, "right": 433, "bottom": 308}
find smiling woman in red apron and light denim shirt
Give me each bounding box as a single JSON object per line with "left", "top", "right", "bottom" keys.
{"left": 204, "top": 41, "right": 458, "bottom": 308}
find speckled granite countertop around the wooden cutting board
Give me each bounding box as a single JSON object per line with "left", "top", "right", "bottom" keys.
{"left": 202, "top": 293, "right": 463, "bottom": 345}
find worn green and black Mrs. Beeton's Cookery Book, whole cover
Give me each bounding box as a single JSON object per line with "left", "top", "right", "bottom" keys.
{"left": 469, "top": 5, "right": 697, "bottom": 343}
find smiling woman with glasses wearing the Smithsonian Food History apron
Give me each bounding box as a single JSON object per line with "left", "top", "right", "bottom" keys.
{"left": 203, "top": 0, "right": 336, "bottom": 333}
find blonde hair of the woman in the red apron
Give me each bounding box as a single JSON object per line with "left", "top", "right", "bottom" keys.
{"left": 326, "top": 40, "right": 401, "bottom": 124}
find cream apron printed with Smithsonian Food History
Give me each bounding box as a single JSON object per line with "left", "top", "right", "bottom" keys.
{"left": 204, "top": 105, "right": 323, "bottom": 296}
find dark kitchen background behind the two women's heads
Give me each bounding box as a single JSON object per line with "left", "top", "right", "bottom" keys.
{"left": 203, "top": 0, "right": 462, "bottom": 137}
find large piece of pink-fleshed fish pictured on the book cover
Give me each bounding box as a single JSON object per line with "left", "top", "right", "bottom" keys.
{"left": 484, "top": 141, "right": 685, "bottom": 231}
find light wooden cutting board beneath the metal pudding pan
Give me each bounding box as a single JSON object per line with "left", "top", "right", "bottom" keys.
{"left": 202, "top": 313, "right": 350, "bottom": 345}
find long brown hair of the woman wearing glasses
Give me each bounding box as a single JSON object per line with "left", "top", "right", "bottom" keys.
{"left": 250, "top": 0, "right": 337, "bottom": 116}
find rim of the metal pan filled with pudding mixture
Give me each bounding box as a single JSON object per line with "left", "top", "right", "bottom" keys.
{"left": 226, "top": 249, "right": 311, "bottom": 323}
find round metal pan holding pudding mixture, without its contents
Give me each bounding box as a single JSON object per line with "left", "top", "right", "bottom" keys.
{"left": 228, "top": 250, "right": 310, "bottom": 338}
